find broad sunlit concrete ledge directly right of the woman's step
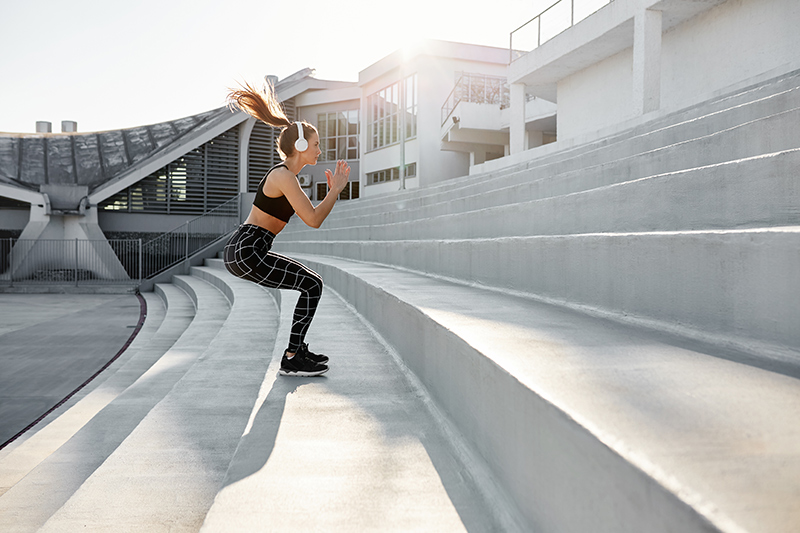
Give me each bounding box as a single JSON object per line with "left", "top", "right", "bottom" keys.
{"left": 290, "top": 254, "right": 800, "bottom": 533}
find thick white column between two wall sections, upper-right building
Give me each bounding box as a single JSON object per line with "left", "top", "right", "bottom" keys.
{"left": 633, "top": 9, "right": 661, "bottom": 115}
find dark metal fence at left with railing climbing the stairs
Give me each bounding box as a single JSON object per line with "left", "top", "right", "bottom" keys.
{"left": 0, "top": 195, "right": 239, "bottom": 287}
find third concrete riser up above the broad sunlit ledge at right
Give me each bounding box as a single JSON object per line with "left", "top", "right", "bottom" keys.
{"left": 296, "top": 98, "right": 800, "bottom": 231}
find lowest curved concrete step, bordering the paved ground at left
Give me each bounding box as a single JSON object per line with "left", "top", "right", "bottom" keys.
{"left": 0, "top": 293, "right": 167, "bottom": 495}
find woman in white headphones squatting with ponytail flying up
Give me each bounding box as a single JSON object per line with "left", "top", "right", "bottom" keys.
{"left": 225, "top": 84, "right": 350, "bottom": 376}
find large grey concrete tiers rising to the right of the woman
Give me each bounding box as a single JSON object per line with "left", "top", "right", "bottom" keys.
{"left": 275, "top": 68, "right": 800, "bottom": 532}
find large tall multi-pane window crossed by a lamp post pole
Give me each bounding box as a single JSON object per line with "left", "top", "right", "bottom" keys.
{"left": 367, "top": 74, "right": 417, "bottom": 150}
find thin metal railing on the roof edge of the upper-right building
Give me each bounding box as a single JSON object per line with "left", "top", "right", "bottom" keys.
{"left": 508, "top": 0, "right": 613, "bottom": 63}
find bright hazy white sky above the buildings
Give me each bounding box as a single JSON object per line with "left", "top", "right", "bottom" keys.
{"left": 0, "top": 0, "right": 553, "bottom": 133}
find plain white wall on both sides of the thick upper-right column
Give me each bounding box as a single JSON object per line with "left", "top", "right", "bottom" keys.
{"left": 558, "top": 0, "right": 800, "bottom": 139}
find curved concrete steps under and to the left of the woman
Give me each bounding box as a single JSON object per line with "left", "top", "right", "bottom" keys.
{"left": 0, "top": 259, "right": 524, "bottom": 533}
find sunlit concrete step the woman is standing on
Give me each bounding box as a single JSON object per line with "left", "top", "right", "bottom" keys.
{"left": 201, "top": 289, "right": 527, "bottom": 533}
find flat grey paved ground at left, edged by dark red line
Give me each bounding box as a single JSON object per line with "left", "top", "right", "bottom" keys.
{"left": 0, "top": 294, "right": 140, "bottom": 444}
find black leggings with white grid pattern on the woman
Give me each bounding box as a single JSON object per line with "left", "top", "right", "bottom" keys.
{"left": 225, "top": 224, "right": 322, "bottom": 353}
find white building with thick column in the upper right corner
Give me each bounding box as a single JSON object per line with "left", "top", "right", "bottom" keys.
{"left": 508, "top": 0, "right": 800, "bottom": 154}
